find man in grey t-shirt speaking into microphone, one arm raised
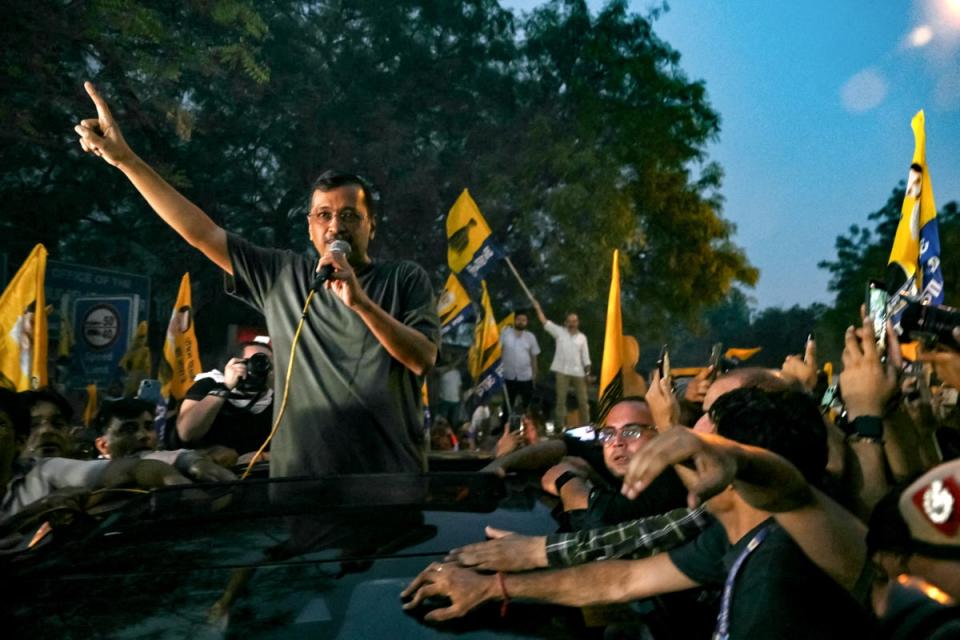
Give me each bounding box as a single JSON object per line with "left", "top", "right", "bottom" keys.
{"left": 75, "top": 83, "right": 440, "bottom": 477}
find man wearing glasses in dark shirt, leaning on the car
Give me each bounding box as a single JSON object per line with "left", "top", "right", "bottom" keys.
{"left": 541, "top": 397, "right": 687, "bottom": 531}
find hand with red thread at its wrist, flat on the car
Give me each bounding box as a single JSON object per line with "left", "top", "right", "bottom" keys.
{"left": 400, "top": 562, "right": 499, "bottom": 622}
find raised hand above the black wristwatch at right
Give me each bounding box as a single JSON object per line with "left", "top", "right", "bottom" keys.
{"left": 840, "top": 317, "right": 899, "bottom": 420}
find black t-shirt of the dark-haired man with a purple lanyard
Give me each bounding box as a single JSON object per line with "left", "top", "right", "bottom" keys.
{"left": 669, "top": 520, "right": 873, "bottom": 640}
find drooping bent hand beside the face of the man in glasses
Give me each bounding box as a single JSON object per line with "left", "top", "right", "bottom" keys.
{"left": 622, "top": 427, "right": 738, "bottom": 508}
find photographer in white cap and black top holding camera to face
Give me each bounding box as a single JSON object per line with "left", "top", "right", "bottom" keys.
{"left": 176, "top": 336, "right": 273, "bottom": 456}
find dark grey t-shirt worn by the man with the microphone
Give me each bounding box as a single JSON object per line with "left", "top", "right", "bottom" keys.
{"left": 227, "top": 234, "right": 440, "bottom": 477}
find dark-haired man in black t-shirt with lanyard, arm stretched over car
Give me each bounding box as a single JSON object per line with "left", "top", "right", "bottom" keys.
{"left": 403, "top": 382, "right": 871, "bottom": 638}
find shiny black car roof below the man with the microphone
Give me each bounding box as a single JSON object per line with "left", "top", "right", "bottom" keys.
{"left": 0, "top": 473, "right": 599, "bottom": 640}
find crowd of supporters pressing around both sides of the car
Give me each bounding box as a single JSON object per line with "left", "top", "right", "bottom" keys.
{"left": 0, "top": 310, "right": 960, "bottom": 638}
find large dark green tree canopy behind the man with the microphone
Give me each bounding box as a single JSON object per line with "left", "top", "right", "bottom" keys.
{"left": 0, "top": 0, "right": 757, "bottom": 355}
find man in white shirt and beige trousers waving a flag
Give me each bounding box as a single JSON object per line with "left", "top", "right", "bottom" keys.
{"left": 535, "top": 303, "right": 590, "bottom": 427}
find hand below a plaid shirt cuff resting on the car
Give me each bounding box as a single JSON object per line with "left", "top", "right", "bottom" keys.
{"left": 444, "top": 527, "right": 548, "bottom": 571}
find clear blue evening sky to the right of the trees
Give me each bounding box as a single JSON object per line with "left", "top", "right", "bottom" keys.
{"left": 502, "top": 0, "right": 960, "bottom": 308}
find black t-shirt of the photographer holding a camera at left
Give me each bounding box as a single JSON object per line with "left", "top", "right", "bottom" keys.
{"left": 179, "top": 378, "right": 273, "bottom": 455}
